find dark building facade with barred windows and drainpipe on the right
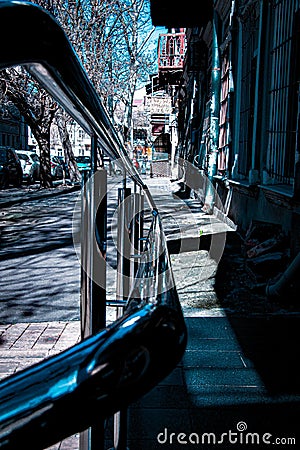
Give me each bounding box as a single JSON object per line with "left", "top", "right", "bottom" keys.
{"left": 153, "top": 0, "right": 300, "bottom": 255}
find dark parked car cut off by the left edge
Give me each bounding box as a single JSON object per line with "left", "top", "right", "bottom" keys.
{"left": 0, "top": 147, "right": 23, "bottom": 189}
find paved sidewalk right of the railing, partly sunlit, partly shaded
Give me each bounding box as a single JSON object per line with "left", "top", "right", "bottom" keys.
{"left": 125, "top": 179, "right": 300, "bottom": 450}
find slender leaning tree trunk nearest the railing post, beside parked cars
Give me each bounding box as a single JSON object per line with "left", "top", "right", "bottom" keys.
{"left": 55, "top": 112, "right": 81, "bottom": 183}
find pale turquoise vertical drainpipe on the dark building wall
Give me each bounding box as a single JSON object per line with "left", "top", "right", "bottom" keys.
{"left": 203, "top": 7, "right": 221, "bottom": 214}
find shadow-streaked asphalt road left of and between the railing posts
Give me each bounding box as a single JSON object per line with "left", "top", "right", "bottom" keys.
{"left": 0, "top": 177, "right": 148, "bottom": 324}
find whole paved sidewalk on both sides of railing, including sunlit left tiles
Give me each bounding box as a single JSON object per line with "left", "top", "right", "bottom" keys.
{"left": 0, "top": 178, "right": 300, "bottom": 450}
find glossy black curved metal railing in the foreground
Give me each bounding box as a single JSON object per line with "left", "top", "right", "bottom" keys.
{"left": 0, "top": 1, "right": 186, "bottom": 450}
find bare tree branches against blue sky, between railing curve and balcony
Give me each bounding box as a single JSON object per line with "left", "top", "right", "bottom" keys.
{"left": 44, "top": 0, "right": 156, "bottom": 140}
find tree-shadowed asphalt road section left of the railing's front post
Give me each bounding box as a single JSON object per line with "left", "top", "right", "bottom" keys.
{"left": 0, "top": 186, "right": 80, "bottom": 323}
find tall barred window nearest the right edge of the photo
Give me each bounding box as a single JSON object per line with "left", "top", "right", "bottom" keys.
{"left": 266, "top": 0, "right": 300, "bottom": 185}
